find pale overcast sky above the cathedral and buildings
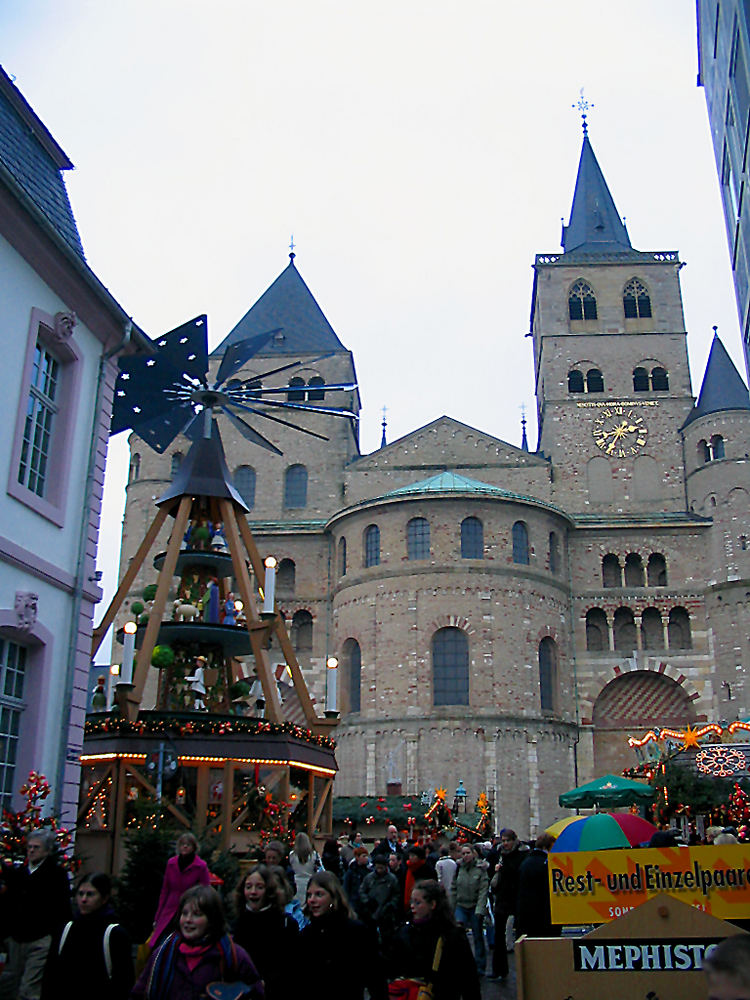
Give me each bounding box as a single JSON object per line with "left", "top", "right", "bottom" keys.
{"left": 0, "top": 0, "right": 745, "bottom": 652}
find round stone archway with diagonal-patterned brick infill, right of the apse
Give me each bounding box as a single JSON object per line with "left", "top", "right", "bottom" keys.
{"left": 593, "top": 670, "right": 696, "bottom": 774}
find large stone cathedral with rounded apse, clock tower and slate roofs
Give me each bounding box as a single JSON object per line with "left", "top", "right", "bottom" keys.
{"left": 119, "top": 134, "right": 750, "bottom": 833}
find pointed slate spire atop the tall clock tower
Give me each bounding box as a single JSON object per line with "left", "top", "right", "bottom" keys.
{"left": 562, "top": 130, "right": 633, "bottom": 253}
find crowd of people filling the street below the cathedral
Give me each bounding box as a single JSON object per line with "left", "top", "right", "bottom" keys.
{"left": 0, "top": 826, "right": 744, "bottom": 1000}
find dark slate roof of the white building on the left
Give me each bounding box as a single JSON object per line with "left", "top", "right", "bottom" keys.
{"left": 0, "top": 67, "right": 84, "bottom": 257}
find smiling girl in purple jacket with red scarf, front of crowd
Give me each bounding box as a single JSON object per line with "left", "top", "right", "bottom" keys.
{"left": 130, "top": 885, "right": 264, "bottom": 1000}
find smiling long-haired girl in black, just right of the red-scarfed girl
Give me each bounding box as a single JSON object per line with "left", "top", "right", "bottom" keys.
{"left": 234, "top": 865, "right": 299, "bottom": 1000}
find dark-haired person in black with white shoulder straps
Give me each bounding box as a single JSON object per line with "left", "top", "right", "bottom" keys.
{"left": 42, "top": 872, "right": 135, "bottom": 1000}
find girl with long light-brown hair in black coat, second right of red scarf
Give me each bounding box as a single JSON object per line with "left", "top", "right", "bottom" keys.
{"left": 297, "top": 871, "right": 387, "bottom": 1000}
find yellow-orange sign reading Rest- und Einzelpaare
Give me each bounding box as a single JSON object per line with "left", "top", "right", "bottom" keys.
{"left": 549, "top": 844, "right": 750, "bottom": 924}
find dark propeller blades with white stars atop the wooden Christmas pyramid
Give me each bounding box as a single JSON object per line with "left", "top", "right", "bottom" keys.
{"left": 110, "top": 316, "right": 357, "bottom": 455}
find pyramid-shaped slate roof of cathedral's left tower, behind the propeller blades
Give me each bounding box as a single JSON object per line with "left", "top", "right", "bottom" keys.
{"left": 211, "top": 260, "right": 346, "bottom": 358}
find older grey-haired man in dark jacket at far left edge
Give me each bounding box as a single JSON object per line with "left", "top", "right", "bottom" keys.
{"left": 0, "top": 829, "right": 70, "bottom": 1000}
